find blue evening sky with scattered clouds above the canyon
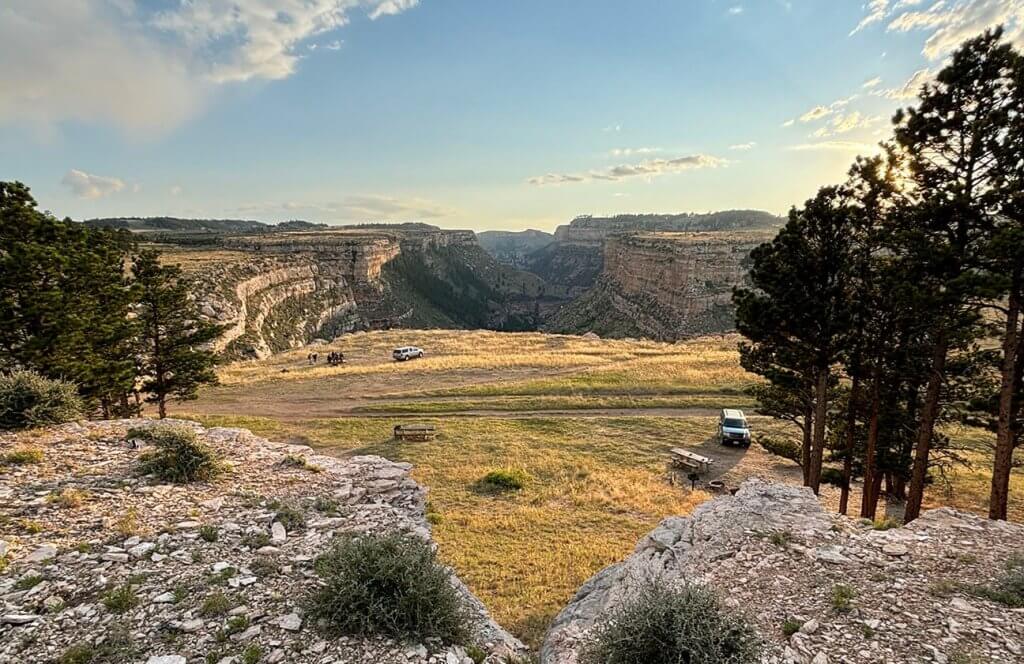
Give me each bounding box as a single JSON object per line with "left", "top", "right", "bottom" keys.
{"left": 0, "top": 0, "right": 1024, "bottom": 231}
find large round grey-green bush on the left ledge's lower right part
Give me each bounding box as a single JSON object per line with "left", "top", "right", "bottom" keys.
{"left": 307, "top": 534, "right": 470, "bottom": 644}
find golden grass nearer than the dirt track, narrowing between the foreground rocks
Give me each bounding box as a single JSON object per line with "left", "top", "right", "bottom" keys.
{"left": 182, "top": 416, "right": 710, "bottom": 647}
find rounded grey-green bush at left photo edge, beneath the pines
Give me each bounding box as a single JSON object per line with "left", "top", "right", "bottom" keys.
{"left": 0, "top": 371, "right": 84, "bottom": 429}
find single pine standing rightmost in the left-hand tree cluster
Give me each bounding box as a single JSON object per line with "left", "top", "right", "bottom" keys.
{"left": 132, "top": 250, "right": 222, "bottom": 418}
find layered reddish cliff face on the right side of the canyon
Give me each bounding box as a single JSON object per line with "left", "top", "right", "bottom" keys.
{"left": 549, "top": 231, "right": 771, "bottom": 340}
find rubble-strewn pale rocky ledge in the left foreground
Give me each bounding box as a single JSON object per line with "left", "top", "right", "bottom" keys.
{"left": 0, "top": 420, "right": 522, "bottom": 664}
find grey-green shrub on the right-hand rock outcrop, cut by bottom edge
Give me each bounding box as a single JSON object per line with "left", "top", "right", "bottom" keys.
{"left": 581, "top": 581, "right": 761, "bottom": 664}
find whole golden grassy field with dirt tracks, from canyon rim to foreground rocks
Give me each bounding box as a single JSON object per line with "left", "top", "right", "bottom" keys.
{"left": 180, "top": 330, "right": 1024, "bottom": 647}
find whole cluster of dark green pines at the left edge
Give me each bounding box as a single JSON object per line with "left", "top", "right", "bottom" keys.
{"left": 0, "top": 181, "right": 221, "bottom": 417}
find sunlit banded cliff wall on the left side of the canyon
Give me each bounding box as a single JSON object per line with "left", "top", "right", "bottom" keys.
{"left": 194, "top": 224, "right": 560, "bottom": 358}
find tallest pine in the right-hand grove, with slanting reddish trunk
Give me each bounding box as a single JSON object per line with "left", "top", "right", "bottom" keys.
{"left": 894, "top": 31, "right": 1014, "bottom": 521}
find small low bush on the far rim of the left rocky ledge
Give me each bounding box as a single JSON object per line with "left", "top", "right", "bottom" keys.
{"left": 128, "top": 424, "right": 220, "bottom": 484}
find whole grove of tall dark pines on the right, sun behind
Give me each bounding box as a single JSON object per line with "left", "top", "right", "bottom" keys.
{"left": 733, "top": 30, "right": 1024, "bottom": 522}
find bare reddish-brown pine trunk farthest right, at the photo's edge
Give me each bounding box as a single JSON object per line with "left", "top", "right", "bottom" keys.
{"left": 988, "top": 269, "right": 1021, "bottom": 521}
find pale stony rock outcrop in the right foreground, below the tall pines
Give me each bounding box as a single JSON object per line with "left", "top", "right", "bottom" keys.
{"left": 541, "top": 480, "right": 1024, "bottom": 664}
